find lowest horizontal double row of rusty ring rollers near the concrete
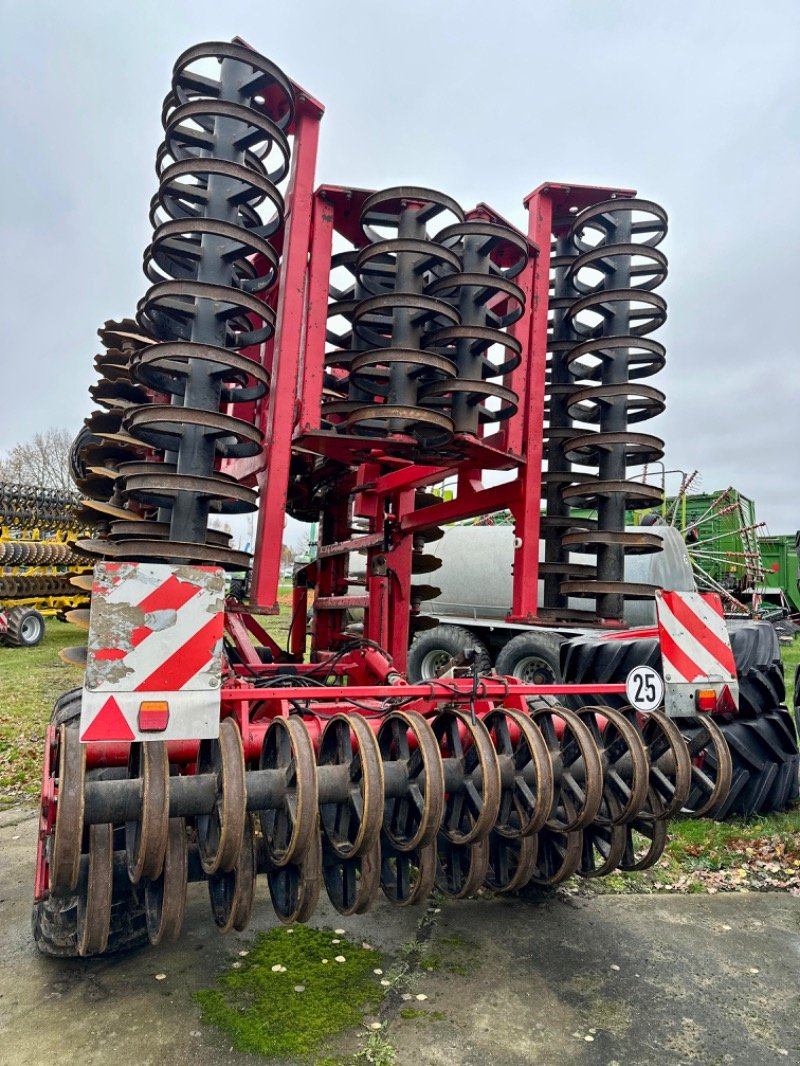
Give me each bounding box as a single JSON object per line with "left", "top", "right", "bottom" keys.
{"left": 34, "top": 695, "right": 730, "bottom": 954}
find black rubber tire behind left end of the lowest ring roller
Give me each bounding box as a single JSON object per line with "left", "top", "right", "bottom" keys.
{"left": 31, "top": 689, "right": 148, "bottom": 958}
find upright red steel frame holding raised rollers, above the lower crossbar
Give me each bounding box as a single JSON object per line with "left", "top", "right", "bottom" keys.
{"left": 220, "top": 166, "right": 635, "bottom": 673}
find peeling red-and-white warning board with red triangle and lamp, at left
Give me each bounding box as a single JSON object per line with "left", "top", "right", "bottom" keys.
{"left": 81, "top": 563, "right": 225, "bottom": 742}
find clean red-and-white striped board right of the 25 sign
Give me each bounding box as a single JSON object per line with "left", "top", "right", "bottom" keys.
{"left": 656, "top": 592, "right": 736, "bottom": 683}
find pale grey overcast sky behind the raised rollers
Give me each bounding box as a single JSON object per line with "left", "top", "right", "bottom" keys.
{"left": 0, "top": 0, "right": 800, "bottom": 533}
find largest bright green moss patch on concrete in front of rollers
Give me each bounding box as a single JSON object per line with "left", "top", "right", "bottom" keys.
{"left": 194, "top": 925, "right": 383, "bottom": 1059}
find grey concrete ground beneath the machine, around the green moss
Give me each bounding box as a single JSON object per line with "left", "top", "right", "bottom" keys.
{"left": 0, "top": 808, "right": 800, "bottom": 1066}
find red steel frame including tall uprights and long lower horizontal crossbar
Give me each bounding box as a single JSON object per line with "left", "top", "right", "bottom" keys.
{"left": 87, "top": 78, "right": 652, "bottom": 741}
